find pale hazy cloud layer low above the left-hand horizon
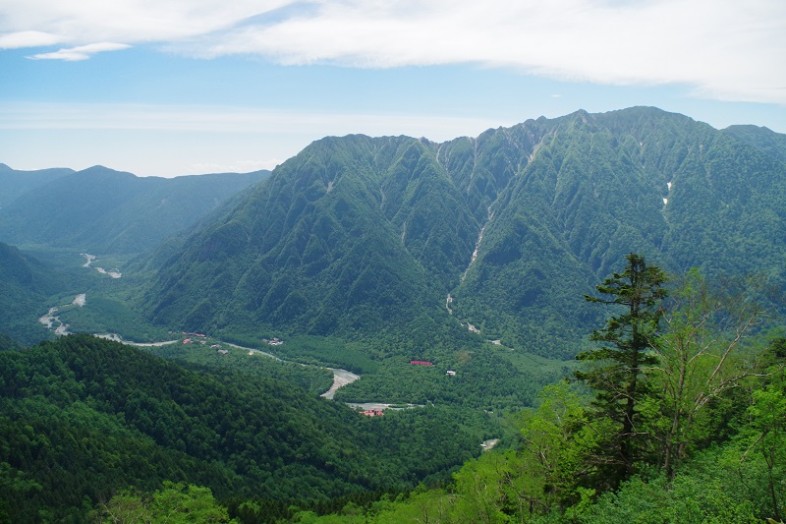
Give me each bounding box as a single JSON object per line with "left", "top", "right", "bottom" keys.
{"left": 0, "top": 102, "right": 502, "bottom": 176}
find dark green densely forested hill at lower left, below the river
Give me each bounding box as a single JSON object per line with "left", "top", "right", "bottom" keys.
{"left": 0, "top": 335, "right": 479, "bottom": 522}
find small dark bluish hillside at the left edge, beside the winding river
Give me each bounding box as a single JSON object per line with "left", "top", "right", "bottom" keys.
{"left": 0, "top": 242, "right": 58, "bottom": 343}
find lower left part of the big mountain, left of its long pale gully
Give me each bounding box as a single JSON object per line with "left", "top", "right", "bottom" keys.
{"left": 145, "top": 136, "right": 479, "bottom": 340}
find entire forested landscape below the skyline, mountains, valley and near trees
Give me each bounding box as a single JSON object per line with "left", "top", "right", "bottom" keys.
{"left": 0, "top": 107, "right": 786, "bottom": 523}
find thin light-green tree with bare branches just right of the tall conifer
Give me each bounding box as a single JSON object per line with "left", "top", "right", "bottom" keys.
{"left": 639, "top": 270, "right": 761, "bottom": 477}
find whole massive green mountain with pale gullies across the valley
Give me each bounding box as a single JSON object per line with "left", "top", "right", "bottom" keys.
{"left": 145, "top": 107, "right": 786, "bottom": 356}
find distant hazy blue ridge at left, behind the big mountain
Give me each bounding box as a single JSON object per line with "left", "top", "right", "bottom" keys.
{"left": 0, "top": 166, "right": 268, "bottom": 254}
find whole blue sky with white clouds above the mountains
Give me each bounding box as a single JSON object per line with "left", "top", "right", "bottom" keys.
{"left": 0, "top": 0, "right": 786, "bottom": 176}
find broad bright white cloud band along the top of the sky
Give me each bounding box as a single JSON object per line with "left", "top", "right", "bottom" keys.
{"left": 0, "top": 0, "right": 786, "bottom": 104}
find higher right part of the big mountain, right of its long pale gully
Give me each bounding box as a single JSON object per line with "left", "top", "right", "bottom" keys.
{"left": 452, "top": 108, "right": 786, "bottom": 352}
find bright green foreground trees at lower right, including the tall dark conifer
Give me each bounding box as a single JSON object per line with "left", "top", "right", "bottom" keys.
{"left": 250, "top": 255, "right": 786, "bottom": 524}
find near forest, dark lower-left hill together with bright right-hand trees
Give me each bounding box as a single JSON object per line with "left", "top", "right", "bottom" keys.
{"left": 0, "top": 255, "right": 786, "bottom": 523}
